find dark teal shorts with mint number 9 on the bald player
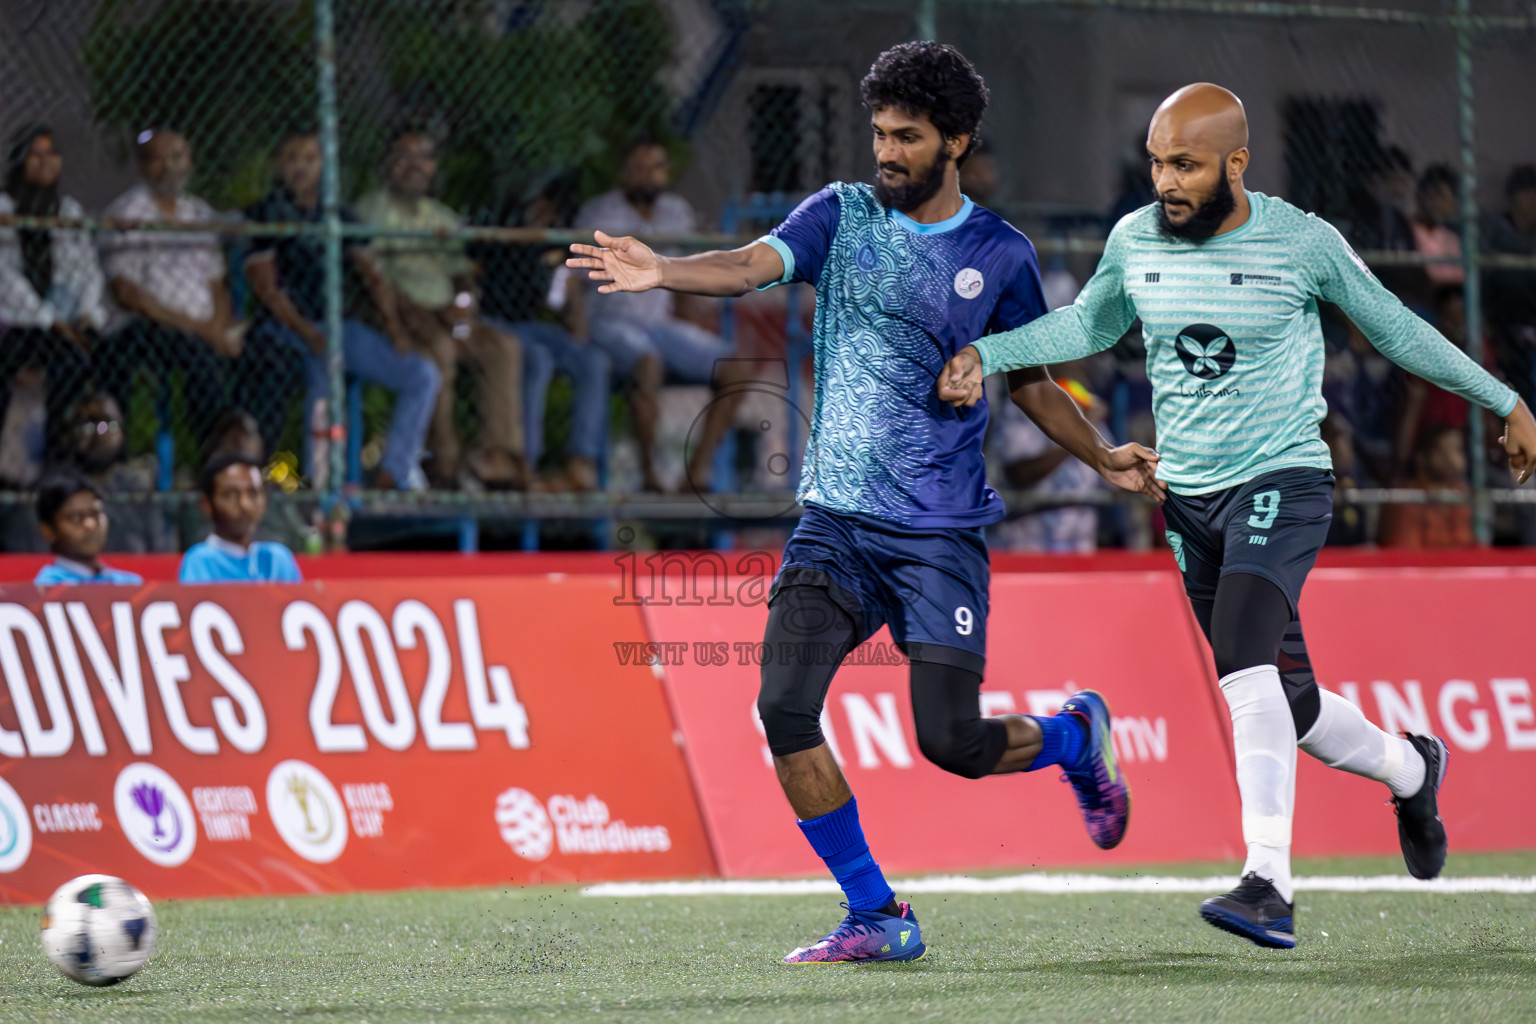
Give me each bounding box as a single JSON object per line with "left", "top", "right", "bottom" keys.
{"left": 1163, "top": 467, "right": 1333, "bottom": 614}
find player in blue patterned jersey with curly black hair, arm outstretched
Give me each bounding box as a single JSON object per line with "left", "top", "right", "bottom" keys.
{"left": 568, "top": 43, "right": 1158, "bottom": 964}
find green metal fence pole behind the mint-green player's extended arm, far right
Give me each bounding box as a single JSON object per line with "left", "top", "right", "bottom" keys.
{"left": 1455, "top": 0, "right": 1493, "bottom": 543}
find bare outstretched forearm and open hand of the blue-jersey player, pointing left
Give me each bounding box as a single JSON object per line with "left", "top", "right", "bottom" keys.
{"left": 565, "top": 232, "right": 783, "bottom": 296}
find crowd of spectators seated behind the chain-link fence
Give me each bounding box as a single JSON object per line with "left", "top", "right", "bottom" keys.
{"left": 0, "top": 117, "right": 1536, "bottom": 551}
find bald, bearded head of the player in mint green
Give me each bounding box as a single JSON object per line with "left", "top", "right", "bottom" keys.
{"left": 1147, "top": 81, "right": 1249, "bottom": 243}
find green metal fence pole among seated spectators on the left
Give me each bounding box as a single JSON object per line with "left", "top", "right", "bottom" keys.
{"left": 315, "top": 0, "right": 347, "bottom": 522}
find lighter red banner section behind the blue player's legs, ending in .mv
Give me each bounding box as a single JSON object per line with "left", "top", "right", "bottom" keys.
{"left": 645, "top": 574, "right": 1243, "bottom": 877}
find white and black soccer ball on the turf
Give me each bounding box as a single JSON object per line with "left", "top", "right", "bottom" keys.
{"left": 43, "top": 875, "right": 158, "bottom": 986}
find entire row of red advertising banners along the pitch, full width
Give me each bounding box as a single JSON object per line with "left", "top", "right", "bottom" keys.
{"left": 0, "top": 553, "right": 1536, "bottom": 903}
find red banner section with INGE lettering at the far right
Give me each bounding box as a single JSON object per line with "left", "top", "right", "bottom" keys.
{"left": 1295, "top": 568, "right": 1536, "bottom": 857}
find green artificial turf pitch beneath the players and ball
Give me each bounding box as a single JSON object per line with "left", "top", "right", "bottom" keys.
{"left": 0, "top": 854, "right": 1536, "bottom": 1024}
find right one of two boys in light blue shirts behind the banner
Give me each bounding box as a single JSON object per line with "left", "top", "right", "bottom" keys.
{"left": 178, "top": 451, "right": 304, "bottom": 583}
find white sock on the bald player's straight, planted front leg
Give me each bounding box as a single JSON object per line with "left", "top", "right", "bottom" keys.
{"left": 1221, "top": 665, "right": 1296, "bottom": 903}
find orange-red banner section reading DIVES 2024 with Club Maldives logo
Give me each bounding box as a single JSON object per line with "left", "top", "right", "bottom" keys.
{"left": 0, "top": 576, "right": 714, "bottom": 903}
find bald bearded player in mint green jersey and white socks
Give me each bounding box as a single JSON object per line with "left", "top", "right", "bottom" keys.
{"left": 938, "top": 84, "right": 1536, "bottom": 949}
